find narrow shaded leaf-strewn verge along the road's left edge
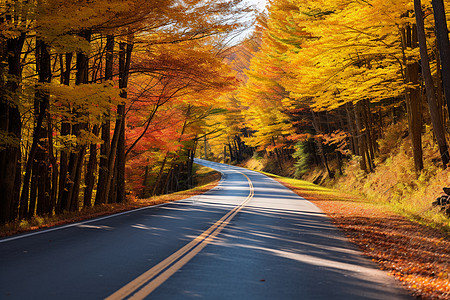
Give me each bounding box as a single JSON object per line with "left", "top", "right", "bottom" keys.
{"left": 0, "top": 167, "right": 220, "bottom": 237}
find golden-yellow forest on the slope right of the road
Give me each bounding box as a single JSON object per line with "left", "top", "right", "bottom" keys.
{"left": 211, "top": 0, "right": 450, "bottom": 228}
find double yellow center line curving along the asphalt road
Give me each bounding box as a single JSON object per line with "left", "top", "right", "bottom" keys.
{"left": 106, "top": 172, "right": 254, "bottom": 300}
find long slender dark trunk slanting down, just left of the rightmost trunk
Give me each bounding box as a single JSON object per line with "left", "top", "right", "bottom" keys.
{"left": 414, "top": 0, "right": 450, "bottom": 168}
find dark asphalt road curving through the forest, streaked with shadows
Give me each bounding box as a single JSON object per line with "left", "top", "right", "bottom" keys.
{"left": 0, "top": 160, "right": 412, "bottom": 299}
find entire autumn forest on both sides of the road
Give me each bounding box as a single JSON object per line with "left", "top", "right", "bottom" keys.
{"left": 0, "top": 0, "right": 450, "bottom": 230}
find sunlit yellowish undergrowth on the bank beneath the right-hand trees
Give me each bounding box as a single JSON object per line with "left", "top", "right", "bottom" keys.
{"left": 327, "top": 123, "right": 450, "bottom": 233}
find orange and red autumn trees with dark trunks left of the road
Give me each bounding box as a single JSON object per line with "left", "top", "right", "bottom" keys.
{"left": 0, "top": 0, "right": 253, "bottom": 223}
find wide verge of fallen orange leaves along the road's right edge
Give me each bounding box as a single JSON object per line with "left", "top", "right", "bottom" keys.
{"left": 272, "top": 176, "right": 450, "bottom": 299}
